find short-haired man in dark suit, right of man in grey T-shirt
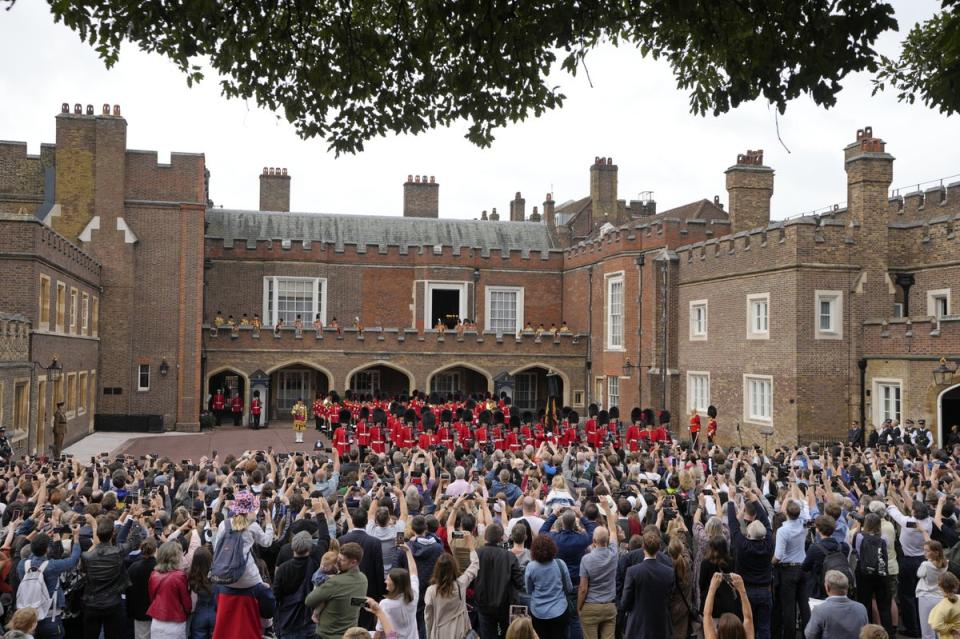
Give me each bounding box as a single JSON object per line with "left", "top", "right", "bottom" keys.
{"left": 620, "top": 528, "right": 674, "bottom": 639}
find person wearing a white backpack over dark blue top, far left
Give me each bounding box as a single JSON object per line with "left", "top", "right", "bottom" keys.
{"left": 16, "top": 525, "right": 80, "bottom": 639}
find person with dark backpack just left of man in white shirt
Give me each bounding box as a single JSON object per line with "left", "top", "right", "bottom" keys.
{"left": 852, "top": 513, "right": 896, "bottom": 637}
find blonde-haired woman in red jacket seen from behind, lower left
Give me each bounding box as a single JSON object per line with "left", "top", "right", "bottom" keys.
{"left": 147, "top": 541, "right": 193, "bottom": 639}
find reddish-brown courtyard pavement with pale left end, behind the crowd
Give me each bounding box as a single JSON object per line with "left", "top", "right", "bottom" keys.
{"left": 64, "top": 422, "right": 329, "bottom": 460}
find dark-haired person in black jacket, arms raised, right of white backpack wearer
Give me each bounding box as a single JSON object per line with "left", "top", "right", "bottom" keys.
{"left": 81, "top": 506, "right": 142, "bottom": 639}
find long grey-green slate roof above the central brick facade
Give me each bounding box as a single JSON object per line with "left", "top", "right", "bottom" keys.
{"left": 206, "top": 208, "right": 560, "bottom": 251}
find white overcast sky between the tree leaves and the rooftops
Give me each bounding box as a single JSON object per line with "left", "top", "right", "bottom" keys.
{"left": 0, "top": 0, "right": 960, "bottom": 218}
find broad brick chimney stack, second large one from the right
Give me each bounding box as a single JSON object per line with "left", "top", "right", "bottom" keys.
{"left": 726, "top": 149, "right": 773, "bottom": 233}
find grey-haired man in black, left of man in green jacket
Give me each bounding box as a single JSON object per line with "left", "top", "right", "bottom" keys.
{"left": 273, "top": 531, "right": 320, "bottom": 639}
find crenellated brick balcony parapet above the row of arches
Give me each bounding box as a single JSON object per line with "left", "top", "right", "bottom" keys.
{"left": 203, "top": 324, "right": 587, "bottom": 357}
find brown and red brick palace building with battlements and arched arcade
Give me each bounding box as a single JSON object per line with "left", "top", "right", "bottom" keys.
{"left": 0, "top": 104, "right": 960, "bottom": 449}
